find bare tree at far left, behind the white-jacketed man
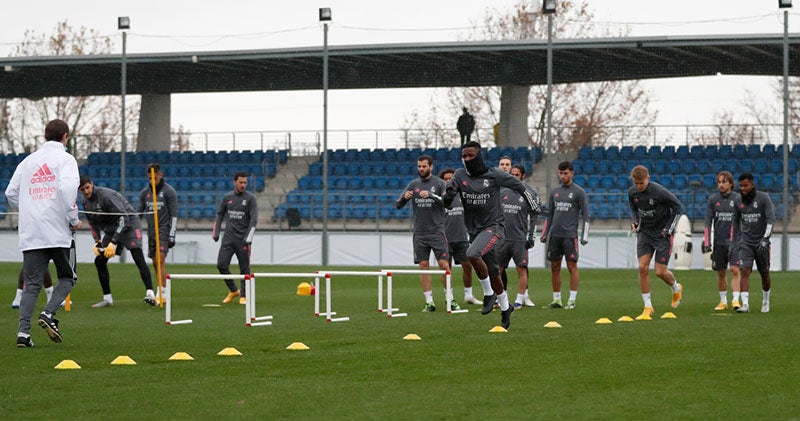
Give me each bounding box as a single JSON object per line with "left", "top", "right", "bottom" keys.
{"left": 0, "top": 21, "right": 139, "bottom": 158}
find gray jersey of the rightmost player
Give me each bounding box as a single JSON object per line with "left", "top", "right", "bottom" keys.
{"left": 733, "top": 191, "right": 775, "bottom": 246}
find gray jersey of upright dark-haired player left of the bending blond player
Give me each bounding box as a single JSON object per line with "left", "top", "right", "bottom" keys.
{"left": 542, "top": 183, "right": 589, "bottom": 238}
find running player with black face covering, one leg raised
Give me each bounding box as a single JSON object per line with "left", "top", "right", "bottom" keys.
{"left": 443, "top": 142, "right": 540, "bottom": 328}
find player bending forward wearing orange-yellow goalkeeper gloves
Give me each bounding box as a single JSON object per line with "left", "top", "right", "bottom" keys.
{"left": 79, "top": 174, "right": 157, "bottom": 308}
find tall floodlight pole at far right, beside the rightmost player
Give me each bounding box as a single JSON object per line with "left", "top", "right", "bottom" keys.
{"left": 778, "top": 0, "right": 792, "bottom": 270}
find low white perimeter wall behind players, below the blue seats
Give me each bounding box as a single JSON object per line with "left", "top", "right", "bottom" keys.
{"left": 0, "top": 231, "right": 800, "bottom": 270}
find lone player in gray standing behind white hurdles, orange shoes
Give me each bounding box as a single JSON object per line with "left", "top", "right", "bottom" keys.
{"left": 211, "top": 171, "right": 258, "bottom": 304}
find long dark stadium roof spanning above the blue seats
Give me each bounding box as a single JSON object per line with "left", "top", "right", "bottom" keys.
{"left": 0, "top": 34, "right": 800, "bottom": 98}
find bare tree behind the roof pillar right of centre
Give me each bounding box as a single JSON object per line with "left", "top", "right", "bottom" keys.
{"left": 406, "top": 0, "right": 657, "bottom": 152}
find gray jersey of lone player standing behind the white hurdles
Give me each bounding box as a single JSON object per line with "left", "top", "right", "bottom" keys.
{"left": 212, "top": 190, "right": 258, "bottom": 243}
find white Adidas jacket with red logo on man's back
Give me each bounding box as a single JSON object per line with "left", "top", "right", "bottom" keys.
{"left": 6, "top": 141, "right": 80, "bottom": 251}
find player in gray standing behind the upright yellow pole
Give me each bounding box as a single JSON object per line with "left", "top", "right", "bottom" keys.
{"left": 137, "top": 162, "right": 178, "bottom": 306}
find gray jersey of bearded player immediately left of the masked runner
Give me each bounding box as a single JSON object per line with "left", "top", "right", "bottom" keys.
{"left": 395, "top": 176, "right": 446, "bottom": 234}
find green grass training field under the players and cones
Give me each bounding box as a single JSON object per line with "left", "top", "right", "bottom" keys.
{"left": 0, "top": 264, "right": 800, "bottom": 419}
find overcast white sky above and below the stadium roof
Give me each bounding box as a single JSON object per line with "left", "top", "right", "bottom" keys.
{"left": 0, "top": 0, "right": 800, "bottom": 136}
